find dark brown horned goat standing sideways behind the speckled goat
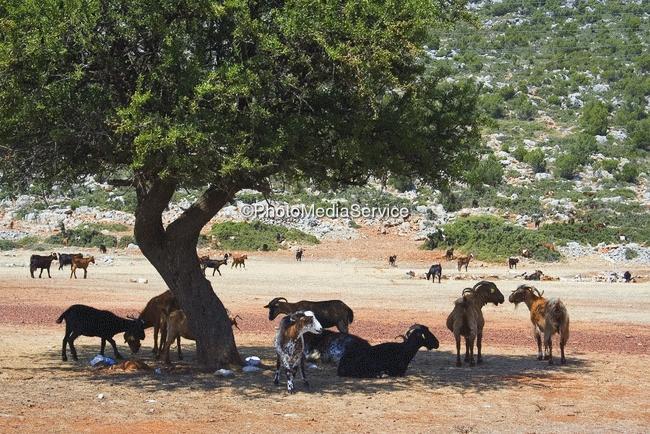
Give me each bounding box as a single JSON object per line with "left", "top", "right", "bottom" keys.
{"left": 264, "top": 297, "right": 354, "bottom": 333}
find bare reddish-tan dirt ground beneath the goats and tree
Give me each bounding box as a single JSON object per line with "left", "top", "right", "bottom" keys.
{"left": 0, "top": 233, "right": 650, "bottom": 432}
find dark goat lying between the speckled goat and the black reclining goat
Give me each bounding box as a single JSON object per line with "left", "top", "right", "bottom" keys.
{"left": 303, "top": 330, "right": 370, "bottom": 364}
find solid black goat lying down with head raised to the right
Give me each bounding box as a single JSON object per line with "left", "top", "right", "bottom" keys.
{"left": 337, "top": 324, "right": 439, "bottom": 378}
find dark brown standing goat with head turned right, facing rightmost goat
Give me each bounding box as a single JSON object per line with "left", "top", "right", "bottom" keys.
{"left": 447, "top": 280, "right": 504, "bottom": 366}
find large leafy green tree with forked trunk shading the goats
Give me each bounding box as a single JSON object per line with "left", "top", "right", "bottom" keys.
{"left": 0, "top": 0, "right": 479, "bottom": 367}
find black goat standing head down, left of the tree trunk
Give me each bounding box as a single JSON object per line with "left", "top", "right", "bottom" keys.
{"left": 56, "top": 304, "right": 144, "bottom": 362}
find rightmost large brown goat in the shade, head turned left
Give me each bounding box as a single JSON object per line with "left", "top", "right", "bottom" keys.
{"left": 508, "top": 284, "right": 569, "bottom": 365}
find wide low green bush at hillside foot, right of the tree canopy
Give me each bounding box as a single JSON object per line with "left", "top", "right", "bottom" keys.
{"left": 436, "top": 217, "right": 560, "bottom": 261}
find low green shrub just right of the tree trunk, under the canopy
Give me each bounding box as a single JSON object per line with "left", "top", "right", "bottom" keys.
{"left": 210, "top": 221, "right": 319, "bottom": 250}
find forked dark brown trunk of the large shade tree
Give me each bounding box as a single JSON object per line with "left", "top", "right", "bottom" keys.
{"left": 135, "top": 176, "right": 242, "bottom": 369}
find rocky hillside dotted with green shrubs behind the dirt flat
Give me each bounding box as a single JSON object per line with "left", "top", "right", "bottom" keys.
{"left": 0, "top": 0, "right": 650, "bottom": 262}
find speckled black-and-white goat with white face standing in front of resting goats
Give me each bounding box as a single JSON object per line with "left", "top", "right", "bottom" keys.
{"left": 273, "top": 311, "right": 323, "bottom": 393}
